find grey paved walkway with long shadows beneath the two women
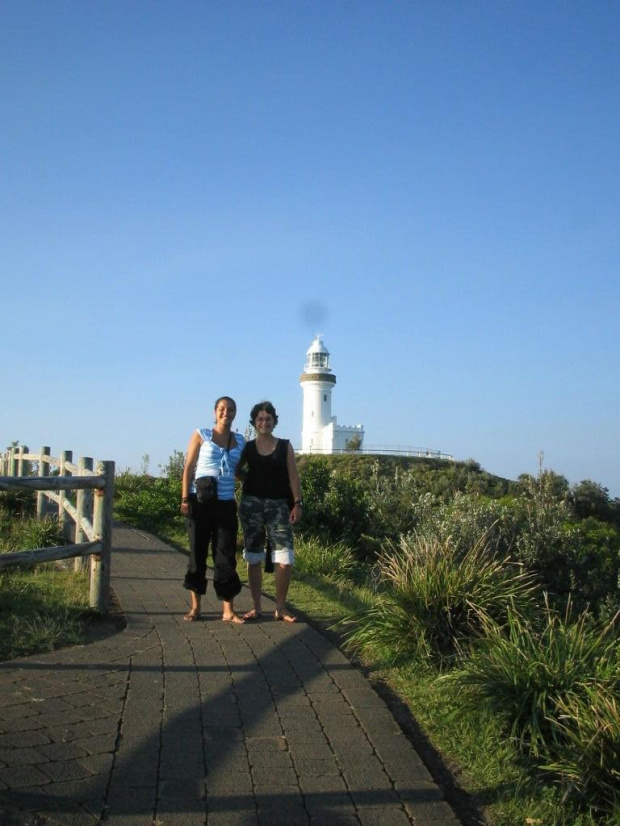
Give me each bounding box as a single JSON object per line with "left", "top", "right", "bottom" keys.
{"left": 0, "top": 528, "right": 459, "bottom": 826}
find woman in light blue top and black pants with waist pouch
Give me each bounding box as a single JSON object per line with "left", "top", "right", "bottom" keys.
{"left": 181, "top": 396, "right": 245, "bottom": 623}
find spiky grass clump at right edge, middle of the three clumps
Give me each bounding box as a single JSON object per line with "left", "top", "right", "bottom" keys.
{"left": 448, "top": 604, "right": 620, "bottom": 758}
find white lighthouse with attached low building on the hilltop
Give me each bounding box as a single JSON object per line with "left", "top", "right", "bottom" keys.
{"left": 299, "top": 335, "right": 364, "bottom": 453}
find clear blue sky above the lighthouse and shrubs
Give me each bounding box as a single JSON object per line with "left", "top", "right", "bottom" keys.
{"left": 0, "top": 0, "right": 620, "bottom": 496}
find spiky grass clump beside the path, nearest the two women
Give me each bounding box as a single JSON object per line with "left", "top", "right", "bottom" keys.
{"left": 346, "top": 534, "right": 538, "bottom": 666}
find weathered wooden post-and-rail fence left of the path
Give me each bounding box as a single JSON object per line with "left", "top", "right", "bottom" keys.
{"left": 0, "top": 446, "right": 114, "bottom": 611}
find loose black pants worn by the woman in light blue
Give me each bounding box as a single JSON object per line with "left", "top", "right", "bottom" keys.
{"left": 183, "top": 496, "right": 241, "bottom": 602}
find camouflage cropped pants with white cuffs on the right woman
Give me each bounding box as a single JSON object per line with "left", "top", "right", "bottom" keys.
{"left": 239, "top": 496, "right": 295, "bottom": 565}
